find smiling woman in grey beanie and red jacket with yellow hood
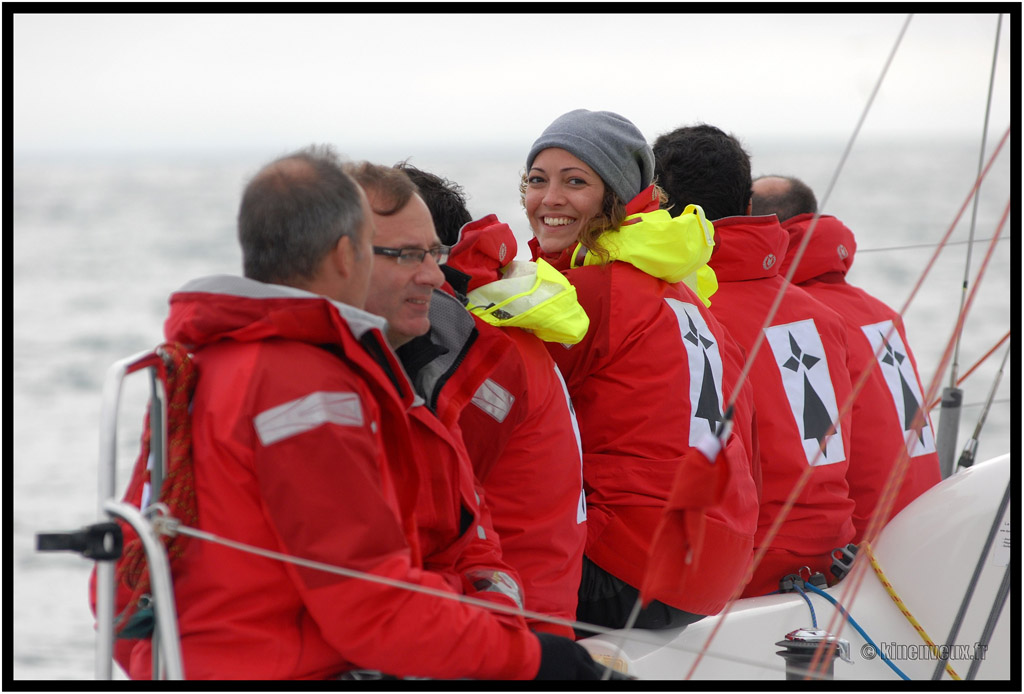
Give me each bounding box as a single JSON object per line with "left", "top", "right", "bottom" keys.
{"left": 520, "top": 110, "right": 758, "bottom": 636}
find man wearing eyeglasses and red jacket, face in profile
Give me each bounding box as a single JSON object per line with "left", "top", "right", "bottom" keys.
{"left": 345, "top": 162, "right": 573, "bottom": 659}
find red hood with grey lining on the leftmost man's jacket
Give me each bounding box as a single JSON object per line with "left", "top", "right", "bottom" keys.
{"left": 164, "top": 275, "right": 386, "bottom": 348}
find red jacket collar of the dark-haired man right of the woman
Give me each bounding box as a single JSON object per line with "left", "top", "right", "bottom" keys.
{"left": 708, "top": 215, "right": 790, "bottom": 281}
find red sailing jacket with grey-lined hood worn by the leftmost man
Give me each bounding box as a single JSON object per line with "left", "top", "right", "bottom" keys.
{"left": 117, "top": 276, "right": 540, "bottom": 680}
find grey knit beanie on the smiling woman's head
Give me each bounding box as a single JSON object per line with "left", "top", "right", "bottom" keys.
{"left": 526, "top": 109, "right": 654, "bottom": 203}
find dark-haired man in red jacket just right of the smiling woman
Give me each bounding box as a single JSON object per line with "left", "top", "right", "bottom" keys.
{"left": 654, "top": 124, "right": 853, "bottom": 596}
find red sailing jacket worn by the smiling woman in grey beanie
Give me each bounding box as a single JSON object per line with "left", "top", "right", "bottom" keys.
{"left": 530, "top": 218, "right": 758, "bottom": 614}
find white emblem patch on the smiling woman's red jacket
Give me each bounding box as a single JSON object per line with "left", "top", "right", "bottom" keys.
{"left": 665, "top": 299, "right": 722, "bottom": 446}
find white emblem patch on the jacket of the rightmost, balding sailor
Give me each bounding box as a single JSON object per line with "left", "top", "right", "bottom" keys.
{"left": 860, "top": 320, "right": 935, "bottom": 458}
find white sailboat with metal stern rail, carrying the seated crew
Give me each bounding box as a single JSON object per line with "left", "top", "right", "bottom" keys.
{"left": 29, "top": 10, "right": 1016, "bottom": 680}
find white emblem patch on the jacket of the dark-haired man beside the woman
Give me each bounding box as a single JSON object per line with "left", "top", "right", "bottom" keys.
{"left": 765, "top": 318, "right": 846, "bottom": 466}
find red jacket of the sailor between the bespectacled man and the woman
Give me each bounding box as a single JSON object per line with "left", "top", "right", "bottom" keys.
{"left": 459, "top": 321, "right": 587, "bottom": 638}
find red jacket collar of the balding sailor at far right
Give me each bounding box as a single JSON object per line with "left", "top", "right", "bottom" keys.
{"left": 778, "top": 212, "right": 857, "bottom": 285}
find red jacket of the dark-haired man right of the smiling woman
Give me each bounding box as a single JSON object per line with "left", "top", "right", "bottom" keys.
{"left": 711, "top": 215, "right": 853, "bottom": 596}
